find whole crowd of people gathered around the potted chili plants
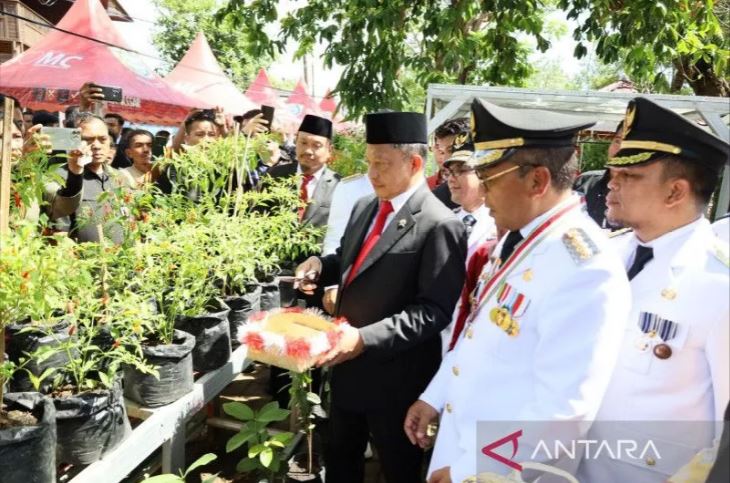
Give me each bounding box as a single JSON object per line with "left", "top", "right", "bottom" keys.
{"left": 1, "top": 83, "right": 730, "bottom": 483}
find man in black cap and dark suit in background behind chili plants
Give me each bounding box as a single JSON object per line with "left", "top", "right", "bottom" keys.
{"left": 268, "top": 114, "right": 340, "bottom": 234}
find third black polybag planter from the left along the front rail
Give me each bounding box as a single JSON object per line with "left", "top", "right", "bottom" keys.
{"left": 124, "top": 330, "right": 195, "bottom": 407}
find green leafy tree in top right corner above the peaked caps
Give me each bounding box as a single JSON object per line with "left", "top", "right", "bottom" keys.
{"left": 558, "top": 0, "right": 730, "bottom": 96}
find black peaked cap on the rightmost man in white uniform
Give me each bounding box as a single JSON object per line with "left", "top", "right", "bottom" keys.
{"left": 606, "top": 97, "right": 730, "bottom": 167}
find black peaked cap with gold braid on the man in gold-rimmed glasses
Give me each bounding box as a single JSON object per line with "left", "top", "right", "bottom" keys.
{"left": 470, "top": 99, "right": 596, "bottom": 167}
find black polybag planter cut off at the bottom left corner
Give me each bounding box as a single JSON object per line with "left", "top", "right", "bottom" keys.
{"left": 0, "top": 392, "right": 56, "bottom": 483}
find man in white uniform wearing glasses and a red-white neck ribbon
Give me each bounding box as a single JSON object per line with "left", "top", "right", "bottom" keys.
{"left": 404, "top": 99, "right": 629, "bottom": 483}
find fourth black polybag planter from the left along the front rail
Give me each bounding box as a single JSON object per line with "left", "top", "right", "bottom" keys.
{"left": 175, "top": 298, "right": 231, "bottom": 372}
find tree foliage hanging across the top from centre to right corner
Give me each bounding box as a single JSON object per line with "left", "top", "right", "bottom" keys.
{"left": 216, "top": 0, "right": 730, "bottom": 117}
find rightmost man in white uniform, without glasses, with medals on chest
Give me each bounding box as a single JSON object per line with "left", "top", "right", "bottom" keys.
{"left": 580, "top": 97, "right": 730, "bottom": 483}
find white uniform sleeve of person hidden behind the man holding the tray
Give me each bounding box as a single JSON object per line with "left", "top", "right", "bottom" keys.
{"left": 322, "top": 174, "right": 374, "bottom": 256}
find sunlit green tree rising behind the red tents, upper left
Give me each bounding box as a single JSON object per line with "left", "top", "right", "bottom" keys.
{"left": 153, "top": 0, "right": 272, "bottom": 89}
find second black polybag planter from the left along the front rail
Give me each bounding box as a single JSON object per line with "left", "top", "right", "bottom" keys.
{"left": 53, "top": 380, "right": 132, "bottom": 465}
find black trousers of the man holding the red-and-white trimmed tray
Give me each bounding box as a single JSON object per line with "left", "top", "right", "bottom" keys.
{"left": 325, "top": 404, "right": 425, "bottom": 483}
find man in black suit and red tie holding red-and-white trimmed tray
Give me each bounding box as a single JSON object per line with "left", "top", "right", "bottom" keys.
{"left": 297, "top": 112, "right": 466, "bottom": 483}
